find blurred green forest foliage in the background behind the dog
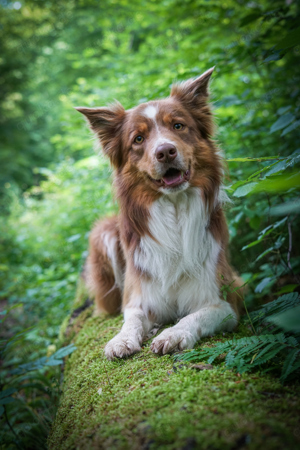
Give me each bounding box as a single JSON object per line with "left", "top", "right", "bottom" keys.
{"left": 0, "top": 0, "right": 300, "bottom": 449}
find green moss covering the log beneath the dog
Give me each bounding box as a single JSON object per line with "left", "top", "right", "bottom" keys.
{"left": 49, "top": 308, "right": 300, "bottom": 450}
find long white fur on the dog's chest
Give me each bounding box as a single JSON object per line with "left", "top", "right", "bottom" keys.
{"left": 134, "top": 188, "right": 220, "bottom": 322}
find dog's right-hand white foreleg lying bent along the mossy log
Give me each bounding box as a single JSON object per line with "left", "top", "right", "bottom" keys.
{"left": 151, "top": 300, "right": 237, "bottom": 355}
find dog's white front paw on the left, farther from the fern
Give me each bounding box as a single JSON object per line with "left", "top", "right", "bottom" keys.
{"left": 104, "top": 333, "right": 141, "bottom": 359}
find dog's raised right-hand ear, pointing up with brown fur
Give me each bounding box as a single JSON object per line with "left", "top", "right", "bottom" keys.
{"left": 170, "top": 67, "right": 214, "bottom": 138}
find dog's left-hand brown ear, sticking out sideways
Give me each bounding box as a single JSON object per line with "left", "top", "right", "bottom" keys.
{"left": 75, "top": 102, "right": 126, "bottom": 168}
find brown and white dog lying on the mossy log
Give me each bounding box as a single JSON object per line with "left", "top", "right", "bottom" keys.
{"left": 76, "top": 69, "right": 241, "bottom": 359}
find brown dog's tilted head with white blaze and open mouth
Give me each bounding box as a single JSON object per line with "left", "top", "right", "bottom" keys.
{"left": 76, "top": 69, "right": 221, "bottom": 194}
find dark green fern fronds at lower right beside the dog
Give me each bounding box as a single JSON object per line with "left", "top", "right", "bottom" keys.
{"left": 175, "top": 293, "right": 300, "bottom": 383}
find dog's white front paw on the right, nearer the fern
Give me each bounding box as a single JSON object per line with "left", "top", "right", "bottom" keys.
{"left": 150, "top": 327, "right": 197, "bottom": 355}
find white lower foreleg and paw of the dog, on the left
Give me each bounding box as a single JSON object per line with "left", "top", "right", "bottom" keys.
{"left": 104, "top": 307, "right": 153, "bottom": 359}
